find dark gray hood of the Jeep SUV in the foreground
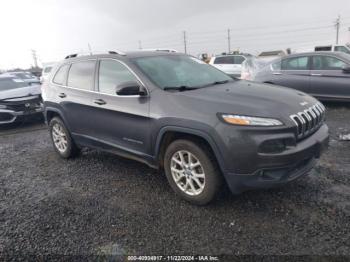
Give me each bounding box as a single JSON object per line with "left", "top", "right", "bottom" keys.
{"left": 177, "top": 80, "right": 318, "bottom": 122}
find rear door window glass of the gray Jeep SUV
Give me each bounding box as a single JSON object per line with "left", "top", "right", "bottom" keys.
{"left": 67, "top": 60, "right": 96, "bottom": 91}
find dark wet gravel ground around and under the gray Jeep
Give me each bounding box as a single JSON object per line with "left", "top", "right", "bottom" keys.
{"left": 0, "top": 104, "right": 350, "bottom": 260}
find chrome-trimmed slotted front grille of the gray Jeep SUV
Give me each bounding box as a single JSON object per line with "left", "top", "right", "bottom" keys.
{"left": 290, "top": 103, "right": 326, "bottom": 139}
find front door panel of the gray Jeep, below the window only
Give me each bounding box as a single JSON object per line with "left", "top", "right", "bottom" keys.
{"left": 90, "top": 93, "right": 150, "bottom": 154}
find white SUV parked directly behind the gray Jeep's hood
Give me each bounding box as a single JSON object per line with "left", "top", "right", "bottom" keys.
{"left": 209, "top": 55, "right": 247, "bottom": 77}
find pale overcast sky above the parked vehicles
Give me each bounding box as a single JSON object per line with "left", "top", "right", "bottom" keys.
{"left": 0, "top": 0, "right": 350, "bottom": 69}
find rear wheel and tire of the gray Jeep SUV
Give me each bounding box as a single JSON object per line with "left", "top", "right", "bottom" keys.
{"left": 49, "top": 117, "right": 79, "bottom": 159}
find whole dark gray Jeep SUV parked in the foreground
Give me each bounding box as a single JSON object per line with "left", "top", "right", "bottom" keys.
{"left": 42, "top": 51, "right": 328, "bottom": 205}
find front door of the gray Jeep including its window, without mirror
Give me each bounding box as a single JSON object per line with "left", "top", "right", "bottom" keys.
{"left": 91, "top": 59, "right": 151, "bottom": 154}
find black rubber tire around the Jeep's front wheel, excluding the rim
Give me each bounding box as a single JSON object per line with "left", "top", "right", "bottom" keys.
{"left": 164, "top": 140, "right": 221, "bottom": 205}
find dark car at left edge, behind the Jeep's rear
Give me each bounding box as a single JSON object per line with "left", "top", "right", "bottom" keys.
{"left": 0, "top": 75, "right": 43, "bottom": 124}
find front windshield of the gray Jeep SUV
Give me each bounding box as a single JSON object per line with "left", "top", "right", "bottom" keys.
{"left": 133, "top": 55, "right": 233, "bottom": 89}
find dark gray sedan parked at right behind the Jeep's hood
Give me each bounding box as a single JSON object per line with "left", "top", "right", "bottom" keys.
{"left": 251, "top": 52, "right": 350, "bottom": 101}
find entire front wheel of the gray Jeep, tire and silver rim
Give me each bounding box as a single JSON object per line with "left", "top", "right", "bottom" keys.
{"left": 164, "top": 139, "right": 222, "bottom": 205}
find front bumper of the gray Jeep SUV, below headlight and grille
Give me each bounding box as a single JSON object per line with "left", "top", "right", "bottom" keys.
{"left": 224, "top": 125, "right": 329, "bottom": 194}
